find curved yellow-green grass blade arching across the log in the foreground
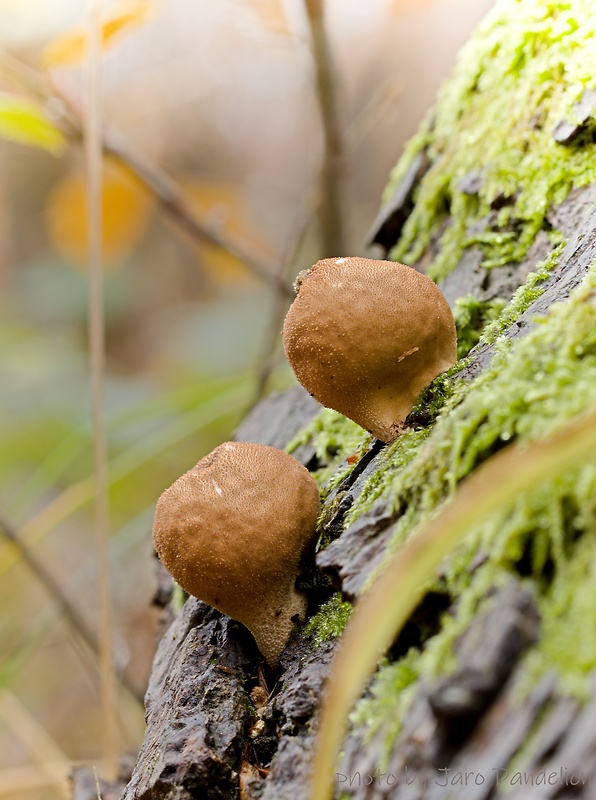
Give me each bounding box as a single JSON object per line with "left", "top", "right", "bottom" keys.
{"left": 310, "top": 406, "right": 596, "bottom": 800}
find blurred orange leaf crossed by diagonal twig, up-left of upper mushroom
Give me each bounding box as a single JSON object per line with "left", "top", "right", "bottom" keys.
{"left": 183, "top": 180, "right": 274, "bottom": 283}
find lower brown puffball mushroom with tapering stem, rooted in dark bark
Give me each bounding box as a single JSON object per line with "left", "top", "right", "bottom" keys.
{"left": 153, "top": 442, "right": 320, "bottom": 667}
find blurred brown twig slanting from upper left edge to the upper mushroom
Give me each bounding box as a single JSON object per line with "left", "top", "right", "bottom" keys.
{"left": 0, "top": 49, "right": 292, "bottom": 297}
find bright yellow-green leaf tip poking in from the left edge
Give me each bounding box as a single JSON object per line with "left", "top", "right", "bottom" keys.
{"left": 0, "top": 93, "right": 66, "bottom": 154}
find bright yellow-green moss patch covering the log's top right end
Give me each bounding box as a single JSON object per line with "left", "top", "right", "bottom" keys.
{"left": 388, "top": 0, "right": 596, "bottom": 280}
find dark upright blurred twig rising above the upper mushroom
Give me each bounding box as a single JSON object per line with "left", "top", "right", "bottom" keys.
{"left": 304, "top": 0, "right": 346, "bottom": 258}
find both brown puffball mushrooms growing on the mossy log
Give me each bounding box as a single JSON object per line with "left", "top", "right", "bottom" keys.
{"left": 153, "top": 258, "right": 457, "bottom": 667}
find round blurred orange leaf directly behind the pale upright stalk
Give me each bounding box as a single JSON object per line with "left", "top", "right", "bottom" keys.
{"left": 47, "top": 160, "right": 154, "bottom": 265}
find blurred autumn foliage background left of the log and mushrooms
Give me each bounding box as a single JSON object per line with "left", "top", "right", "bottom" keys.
{"left": 0, "top": 0, "right": 491, "bottom": 800}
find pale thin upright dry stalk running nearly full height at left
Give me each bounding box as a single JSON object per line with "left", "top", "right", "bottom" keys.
{"left": 83, "top": 6, "right": 118, "bottom": 777}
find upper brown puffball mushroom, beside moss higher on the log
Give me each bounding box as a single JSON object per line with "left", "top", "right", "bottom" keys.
{"left": 283, "top": 258, "right": 457, "bottom": 442}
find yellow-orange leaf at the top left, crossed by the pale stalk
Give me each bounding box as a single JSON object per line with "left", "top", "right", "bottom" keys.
{"left": 41, "top": 0, "right": 154, "bottom": 68}
